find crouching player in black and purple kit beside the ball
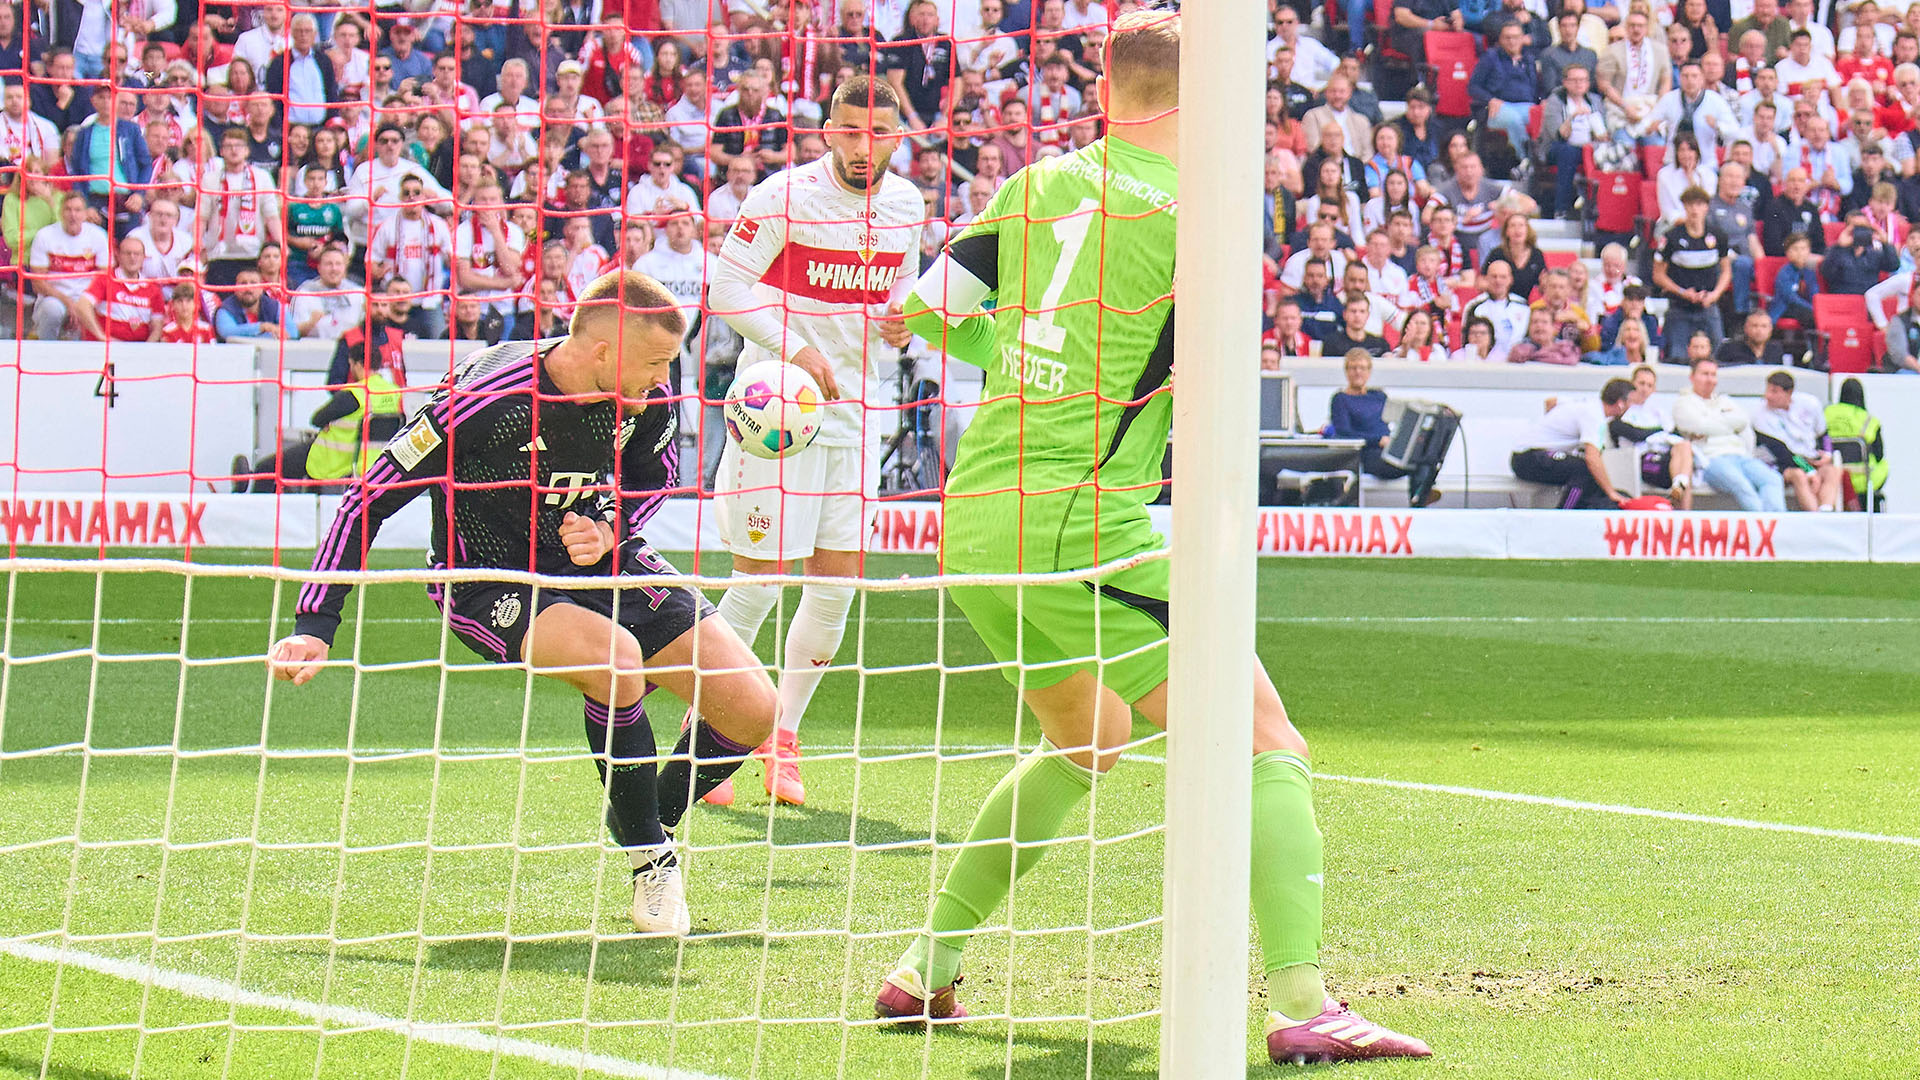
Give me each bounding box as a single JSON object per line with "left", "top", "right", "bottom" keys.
{"left": 267, "top": 271, "right": 776, "bottom": 934}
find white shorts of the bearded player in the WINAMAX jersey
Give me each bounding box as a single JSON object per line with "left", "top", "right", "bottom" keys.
{"left": 714, "top": 438, "right": 879, "bottom": 561}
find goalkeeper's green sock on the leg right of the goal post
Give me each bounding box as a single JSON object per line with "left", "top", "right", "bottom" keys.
{"left": 1252, "top": 749, "right": 1327, "bottom": 1020}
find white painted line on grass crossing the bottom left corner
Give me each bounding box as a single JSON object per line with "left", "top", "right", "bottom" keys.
{"left": 0, "top": 942, "right": 728, "bottom": 1080}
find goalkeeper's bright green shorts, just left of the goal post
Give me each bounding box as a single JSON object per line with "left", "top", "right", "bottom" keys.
{"left": 948, "top": 559, "right": 1169, "bottom": 703}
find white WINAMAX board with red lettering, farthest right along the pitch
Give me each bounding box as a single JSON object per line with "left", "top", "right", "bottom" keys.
{"left": 1490, "top": 509, "right": 1868, "bottom": 561}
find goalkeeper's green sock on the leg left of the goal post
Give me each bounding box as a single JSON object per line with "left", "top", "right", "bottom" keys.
{"left": 900, "top": 742, "right": 1094, "bottom": 990}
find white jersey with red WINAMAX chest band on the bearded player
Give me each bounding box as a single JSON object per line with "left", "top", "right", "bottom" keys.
{"left": 714, "top": 154, "right": 925, "bottom": 446}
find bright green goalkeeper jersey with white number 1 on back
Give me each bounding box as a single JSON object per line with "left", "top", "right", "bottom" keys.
{"left": 906, "top": 136, "right": 1179, "bottom": 573}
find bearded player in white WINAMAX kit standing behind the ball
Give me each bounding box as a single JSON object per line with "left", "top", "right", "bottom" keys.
{"left": 708, "top": 75, "right": 925, "bottom": 805}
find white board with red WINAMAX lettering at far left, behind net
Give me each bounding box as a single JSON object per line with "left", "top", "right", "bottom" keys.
{"left": 0, "top": 492, "right": 315, "bottom": 550}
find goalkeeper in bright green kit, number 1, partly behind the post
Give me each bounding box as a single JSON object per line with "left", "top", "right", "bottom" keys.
{"left": 876, "top": 12, "right": 1430, "bottom": 1061}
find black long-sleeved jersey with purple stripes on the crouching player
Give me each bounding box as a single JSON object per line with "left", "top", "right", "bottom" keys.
{"left": 294, "top": 338, "right": 680, "bottom": 642}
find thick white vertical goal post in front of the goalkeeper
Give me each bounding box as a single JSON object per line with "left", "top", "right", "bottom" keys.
{"left": 1160, "top": 0, "right": 1265, "bottom": 1080}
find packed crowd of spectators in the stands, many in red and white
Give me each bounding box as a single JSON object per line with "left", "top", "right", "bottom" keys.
{"left": 0, "top": 0, "right": 1920, "bottom": 371}
